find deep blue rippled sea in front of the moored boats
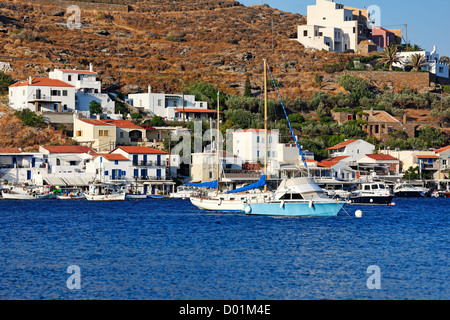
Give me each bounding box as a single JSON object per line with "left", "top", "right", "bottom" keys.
{"left": 0, "top": 198, "right": 450, "bottom": 300}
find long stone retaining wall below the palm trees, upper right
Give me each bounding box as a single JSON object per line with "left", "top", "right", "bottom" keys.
{"left": 348, "top": 70, "right": 433, "bottom": 92}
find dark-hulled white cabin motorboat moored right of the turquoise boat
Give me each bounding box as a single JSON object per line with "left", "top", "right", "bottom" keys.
{"left": 349, "top": 182, "right": 394, "bottom": 205}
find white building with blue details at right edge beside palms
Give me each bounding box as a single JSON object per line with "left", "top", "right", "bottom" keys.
{"left": 392, "top": 46, "right": 449, "bottom": 78}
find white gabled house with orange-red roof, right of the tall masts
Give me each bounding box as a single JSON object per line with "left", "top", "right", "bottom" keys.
{"left": 327, "top": 139, "right": 375, "bottom": 165}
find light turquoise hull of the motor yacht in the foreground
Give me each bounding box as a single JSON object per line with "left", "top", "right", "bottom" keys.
{"left": 244, "top": 201, "right": 344, "bottom": 217}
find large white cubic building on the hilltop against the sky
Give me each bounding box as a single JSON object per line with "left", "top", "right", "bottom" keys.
{"left": 296, "top": 0, "right": 369, "bottom": 52}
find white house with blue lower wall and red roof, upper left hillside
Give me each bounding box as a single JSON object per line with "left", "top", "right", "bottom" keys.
{"left": 49, "top": 64, "right": 115, "bottom": 116}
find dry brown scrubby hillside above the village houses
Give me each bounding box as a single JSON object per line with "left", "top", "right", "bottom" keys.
{"left": 0, "top": 0, "right": 351, "bottom": 96}
